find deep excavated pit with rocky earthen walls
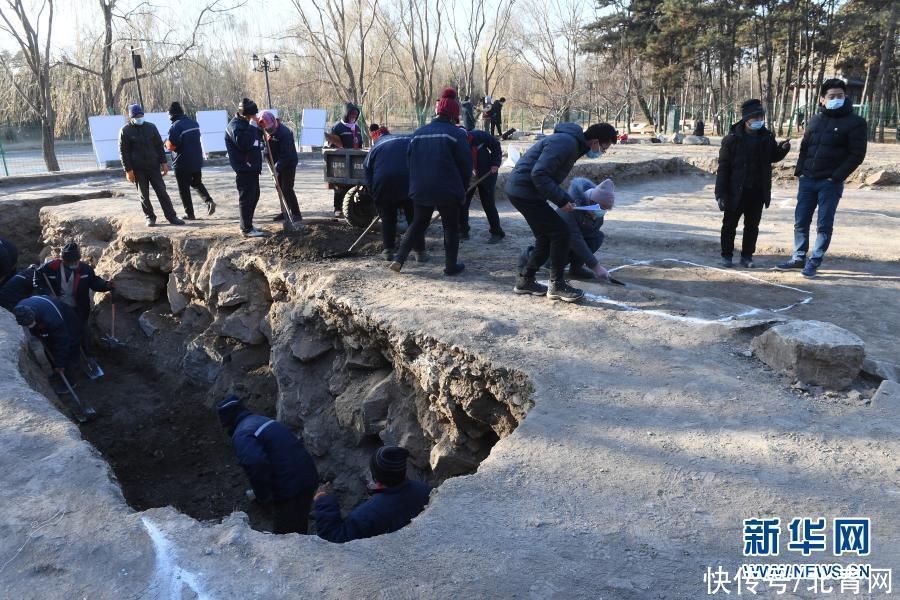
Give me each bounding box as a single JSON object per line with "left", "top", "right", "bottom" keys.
{"left": 45, "top": 239, "right": 533, "bottom": 532}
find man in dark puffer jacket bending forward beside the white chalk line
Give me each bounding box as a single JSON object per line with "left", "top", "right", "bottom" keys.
{"left": 504, "top": 123, "right": 616, "bottom": 302}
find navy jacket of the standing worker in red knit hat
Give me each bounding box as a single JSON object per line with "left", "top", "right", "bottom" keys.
{"left": 407, "top": 117, "right": 472, "bottom": 206}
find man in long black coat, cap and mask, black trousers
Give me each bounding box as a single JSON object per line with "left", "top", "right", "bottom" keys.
{"left": 716, "top": 99, "right": 791, "bottom": 269}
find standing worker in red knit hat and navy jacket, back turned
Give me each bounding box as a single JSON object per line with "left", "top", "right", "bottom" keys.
{"left": 391, "top": 88, "right": 472, "bottom": 275}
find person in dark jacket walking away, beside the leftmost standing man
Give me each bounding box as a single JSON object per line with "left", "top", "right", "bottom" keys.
{"left": 166, "top": 102, "right": 216, "bottom": 219}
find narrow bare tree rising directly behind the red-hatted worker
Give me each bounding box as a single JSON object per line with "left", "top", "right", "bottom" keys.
{"left": 381, "top": 0, "right": 444, "bottom": 125}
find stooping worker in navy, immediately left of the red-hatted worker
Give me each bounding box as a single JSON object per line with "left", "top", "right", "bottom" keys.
{"left": 363, "top": 127, "right": 427, "bottom": 262}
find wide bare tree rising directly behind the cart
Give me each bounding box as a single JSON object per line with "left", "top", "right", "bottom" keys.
{"left": 292, "top": 0, "right": 387, "bottom": 105}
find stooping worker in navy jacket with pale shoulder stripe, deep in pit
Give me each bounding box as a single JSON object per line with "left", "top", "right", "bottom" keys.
{"left": 216, "top": 396, "right": 319, "bottom": 535}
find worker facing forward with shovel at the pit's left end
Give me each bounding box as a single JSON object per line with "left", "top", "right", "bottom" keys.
{"left": 34, "top": 242, "right": 115, "bottom": 356}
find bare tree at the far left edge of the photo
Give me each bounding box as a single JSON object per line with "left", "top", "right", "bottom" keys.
{"left": 0, "top": 0, "right": 59, "bottom": 171}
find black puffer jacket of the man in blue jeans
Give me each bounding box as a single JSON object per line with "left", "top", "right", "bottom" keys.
{"left": 794, "top": 100, "right": 867, "bottom": 182}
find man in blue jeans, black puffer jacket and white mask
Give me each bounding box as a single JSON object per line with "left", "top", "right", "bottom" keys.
{"left": 778, "top": 79, "right": 867, "bottom": 277}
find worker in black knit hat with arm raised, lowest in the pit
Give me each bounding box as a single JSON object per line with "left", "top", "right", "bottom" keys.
{"left": 316, "top": 446, "right": 431, "bottom": 544}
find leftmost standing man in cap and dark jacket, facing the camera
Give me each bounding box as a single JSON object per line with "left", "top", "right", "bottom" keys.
{"left": 119, "top": 104, "right": 184, "bottom": 227}
